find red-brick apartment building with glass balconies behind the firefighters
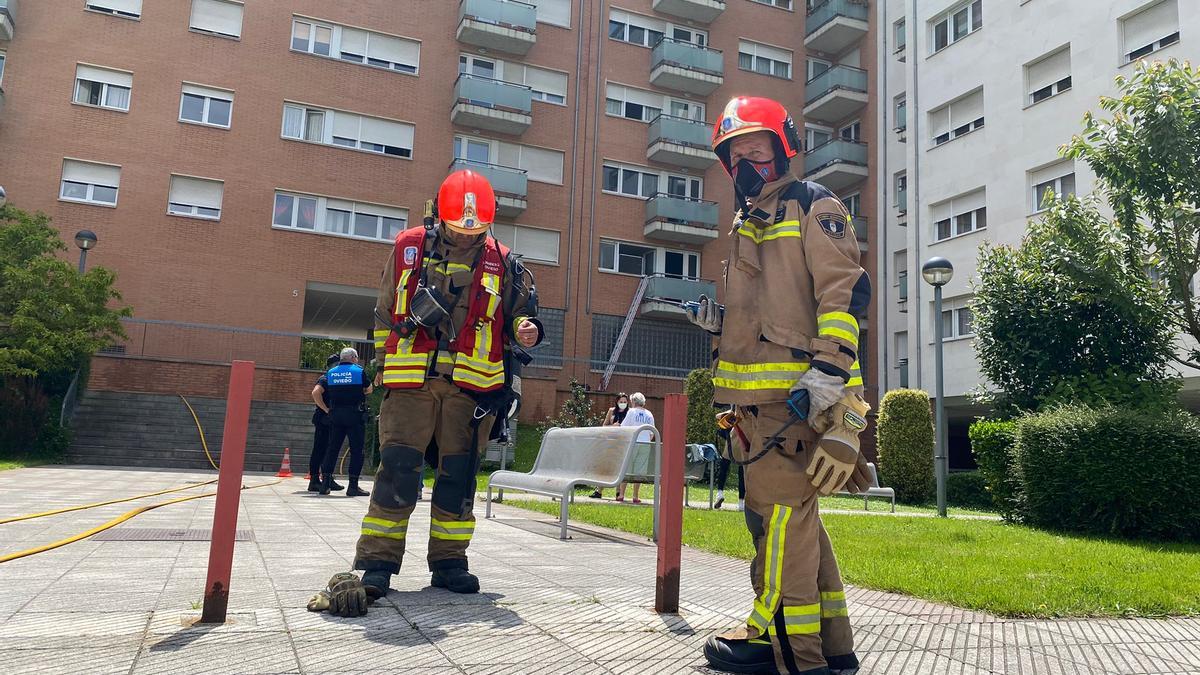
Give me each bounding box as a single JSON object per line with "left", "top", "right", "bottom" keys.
{"left": 0, "top": 0, "right": 878, "bottom": 418}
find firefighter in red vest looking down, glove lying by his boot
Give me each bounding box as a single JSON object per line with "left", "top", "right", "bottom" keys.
{"left": 321, "top": 169, "right": 544, "bottom": 615}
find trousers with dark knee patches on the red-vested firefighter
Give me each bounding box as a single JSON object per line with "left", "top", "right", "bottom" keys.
{"left": 354, "top": 377, "right": 494, "bottom": 574}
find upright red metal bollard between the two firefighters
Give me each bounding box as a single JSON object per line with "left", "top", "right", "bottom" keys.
{"left": 654, "top": 394, "right": 688, "bottom": 614}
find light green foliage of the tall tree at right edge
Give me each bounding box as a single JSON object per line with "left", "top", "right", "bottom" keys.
{"left": 1061, "top": 59, "right": 1200, "bottom": 369}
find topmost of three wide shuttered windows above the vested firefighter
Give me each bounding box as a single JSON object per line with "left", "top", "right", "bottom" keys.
{"left": 292, "top": 17, "right": 421, "bottom": 74}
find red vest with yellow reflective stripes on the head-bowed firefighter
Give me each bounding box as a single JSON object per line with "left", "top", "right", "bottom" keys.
{"left": 383, "top": 227, "right": 509, "bottom": 392}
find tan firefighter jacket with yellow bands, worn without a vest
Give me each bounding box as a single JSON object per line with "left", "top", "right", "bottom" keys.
{"left": 713, "top": 175, "right": 871, "bottom": 407}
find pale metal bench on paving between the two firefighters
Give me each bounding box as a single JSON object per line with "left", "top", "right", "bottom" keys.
{"left": 485, "top": 424, "right": 660, "bottom": 539}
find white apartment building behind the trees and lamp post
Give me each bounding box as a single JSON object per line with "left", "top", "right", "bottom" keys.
{"left": 874, "top": 0, "right": 1200, "bottom": 456}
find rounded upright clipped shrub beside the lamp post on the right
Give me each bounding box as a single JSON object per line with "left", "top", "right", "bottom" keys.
{"left": 877, "top": 389, "right": 934, "bottom": 503}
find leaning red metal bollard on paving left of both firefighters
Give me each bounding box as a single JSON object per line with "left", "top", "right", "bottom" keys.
{"left": 200, "top": 362, "right": 254, "bottom": 623}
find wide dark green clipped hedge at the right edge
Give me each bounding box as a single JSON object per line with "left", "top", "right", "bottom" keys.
{"left": 1015, "top": 405, "right": 1200, "bottom": 540}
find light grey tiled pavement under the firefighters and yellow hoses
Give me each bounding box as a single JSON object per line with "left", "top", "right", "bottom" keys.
{"left": 0, "top": 467, "right": 1200, "bottom": 675}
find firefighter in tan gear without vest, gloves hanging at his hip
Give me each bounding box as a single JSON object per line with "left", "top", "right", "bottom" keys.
{"left": 689, "top": 97, "right": 871, "bottom": 675}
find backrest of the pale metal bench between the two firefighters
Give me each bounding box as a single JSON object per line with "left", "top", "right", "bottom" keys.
{"left": 533, "top": 424, "right": 658, "bottom": 483}
